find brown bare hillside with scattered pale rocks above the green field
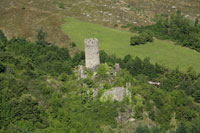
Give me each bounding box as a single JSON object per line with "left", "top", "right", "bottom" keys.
{"left": 0, "top": 0, "right": 200, "bottom": 51}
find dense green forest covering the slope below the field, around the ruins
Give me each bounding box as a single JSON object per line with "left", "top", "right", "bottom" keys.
{"left": 0, "top": 30, "right": 200, "bottom": 133}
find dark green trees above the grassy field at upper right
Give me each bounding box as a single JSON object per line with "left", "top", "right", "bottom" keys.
{"left": 130, "top": 10, "right": 200, "bottom": 52}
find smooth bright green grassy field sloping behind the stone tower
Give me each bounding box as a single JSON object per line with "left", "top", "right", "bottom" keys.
{"left": 62, "top": 18, "right": 200, "bottom": 72}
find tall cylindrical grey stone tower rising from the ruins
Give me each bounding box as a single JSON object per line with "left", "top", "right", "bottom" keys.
{"left": 85, "top": 38, "right": 100, "bottom": 71}
